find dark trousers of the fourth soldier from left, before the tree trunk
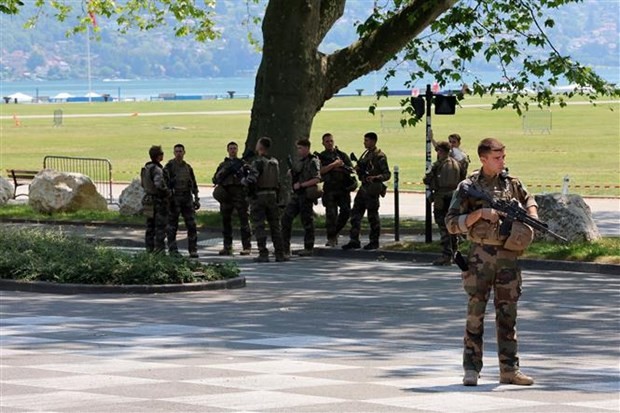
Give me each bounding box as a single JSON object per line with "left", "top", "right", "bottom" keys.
{"left": 250, "top": 191, "right": 284, "bottom": 257}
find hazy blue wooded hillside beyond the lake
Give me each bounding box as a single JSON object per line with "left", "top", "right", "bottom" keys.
{"left": 0, "top": 0, "right": 620, "bottom": 80}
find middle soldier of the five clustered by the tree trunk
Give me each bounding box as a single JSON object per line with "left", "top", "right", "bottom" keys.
{"left": 282, "top": 139, "right": 321, "bottom": 256}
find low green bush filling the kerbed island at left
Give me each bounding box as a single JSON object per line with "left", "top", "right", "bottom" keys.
{"left": 0, "top": 228, "right": 239, "bottom": 285}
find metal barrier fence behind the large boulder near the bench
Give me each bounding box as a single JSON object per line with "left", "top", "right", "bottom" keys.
{"left": 43, "top": 155, "right": 114, "bottom": 204}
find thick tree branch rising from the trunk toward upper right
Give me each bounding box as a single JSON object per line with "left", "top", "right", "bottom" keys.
{"left": 323, "top": 0, "right": 458, "bottom": 99}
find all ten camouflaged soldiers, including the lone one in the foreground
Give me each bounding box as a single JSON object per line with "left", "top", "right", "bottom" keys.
{"left": 141, "top": 132, "right": 538, "bottom": 386}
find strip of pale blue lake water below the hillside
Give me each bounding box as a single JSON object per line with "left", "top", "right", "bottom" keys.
{"left": 0, "top": 68, "right": 619, "bottom": 100}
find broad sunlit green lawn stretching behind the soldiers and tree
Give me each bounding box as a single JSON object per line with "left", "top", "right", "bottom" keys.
{"left": 0, "top": 96, "right": 620, "bottom": 196}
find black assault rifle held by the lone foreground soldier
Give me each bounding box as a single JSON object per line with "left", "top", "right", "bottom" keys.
{"left": 460, "top": 185, "right": 568, "bottom": 242}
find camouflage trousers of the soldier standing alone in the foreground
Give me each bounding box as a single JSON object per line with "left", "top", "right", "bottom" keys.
{"left": 463, "top": 244, "right": 521, "bottom": 372}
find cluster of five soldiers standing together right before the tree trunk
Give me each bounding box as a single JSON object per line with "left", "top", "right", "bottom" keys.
{"left": 213, "top": 132, "right": 391, "bottom": 262}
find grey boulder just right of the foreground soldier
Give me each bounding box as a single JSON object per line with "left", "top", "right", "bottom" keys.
{"left": 536, "top": 194, "right": 601, "bottom": 242}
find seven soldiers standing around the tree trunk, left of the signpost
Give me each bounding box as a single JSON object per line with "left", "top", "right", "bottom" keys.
{"left": 141, "top": 132, "right": 391, "bottom": 262}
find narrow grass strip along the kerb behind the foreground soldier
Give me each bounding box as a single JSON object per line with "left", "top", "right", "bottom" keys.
{"left": 382, "top": 237, "right": 620, "bottom": 264}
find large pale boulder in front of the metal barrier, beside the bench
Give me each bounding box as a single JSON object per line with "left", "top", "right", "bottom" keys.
{"left": 28, "top": 169, "right": 108, "bottom": 214}
